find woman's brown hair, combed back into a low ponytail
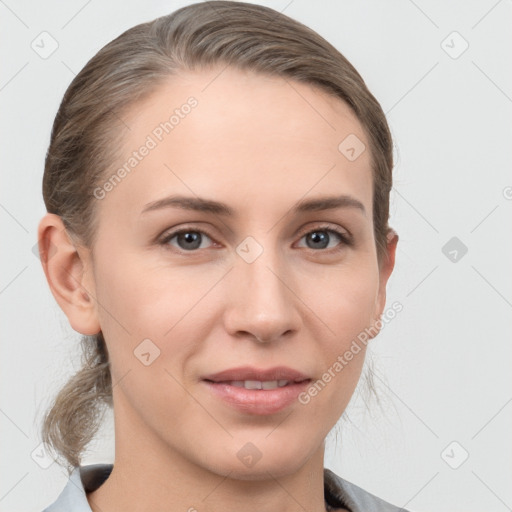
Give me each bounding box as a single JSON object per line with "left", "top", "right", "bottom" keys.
{"left": 42, "top": 0, "right": 393, "bottom": 471}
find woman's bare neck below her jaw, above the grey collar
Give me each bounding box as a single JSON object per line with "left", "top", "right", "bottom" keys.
{"left": 87, "top": 404, "right": 325, "bottom": 512}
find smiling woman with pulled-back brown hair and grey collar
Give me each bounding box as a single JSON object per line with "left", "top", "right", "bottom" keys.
{"left": 38, "top": 1, "right": 404, "bottom": 512}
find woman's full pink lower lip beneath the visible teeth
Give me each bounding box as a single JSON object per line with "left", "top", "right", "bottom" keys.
{"left": 202, "top": 380, "right": 310, "bottom": 415}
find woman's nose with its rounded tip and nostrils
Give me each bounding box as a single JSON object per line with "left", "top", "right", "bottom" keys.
{"left": 224, "top": 244, "right": 301, "bottom": 343}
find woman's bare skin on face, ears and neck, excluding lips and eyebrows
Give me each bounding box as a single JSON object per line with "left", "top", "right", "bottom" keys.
{"left": 39, "top": 68, "right": 398, "bottom": 512}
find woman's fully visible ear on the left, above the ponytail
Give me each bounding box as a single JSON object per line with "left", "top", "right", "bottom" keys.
{"left": 37, "top": 213, "right": 101, "bottom": 335}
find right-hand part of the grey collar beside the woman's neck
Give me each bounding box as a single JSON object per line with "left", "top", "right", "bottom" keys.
{"left": 324, "top": 468, "right": 408, "bottom": 512}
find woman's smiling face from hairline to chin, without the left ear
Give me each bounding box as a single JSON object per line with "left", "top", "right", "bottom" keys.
{"left": 79, "top": 68, "right": 394, "bottom": 478}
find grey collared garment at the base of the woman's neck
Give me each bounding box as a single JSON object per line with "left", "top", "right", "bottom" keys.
{"left": 42, "top": 464, "right": 407, "bottom": 512}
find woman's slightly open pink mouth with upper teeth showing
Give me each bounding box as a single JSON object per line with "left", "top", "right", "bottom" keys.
{"left": 202, "top": 367, "right": 312, "bottom": 415}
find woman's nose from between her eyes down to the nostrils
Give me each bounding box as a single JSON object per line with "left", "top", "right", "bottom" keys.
{"left": 228, "top": 235, "right": 299, "bottom": 341}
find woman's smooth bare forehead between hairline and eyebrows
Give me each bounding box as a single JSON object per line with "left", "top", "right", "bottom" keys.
{"left": 102, "top": 67, "right": 372, "bottom": 220}
